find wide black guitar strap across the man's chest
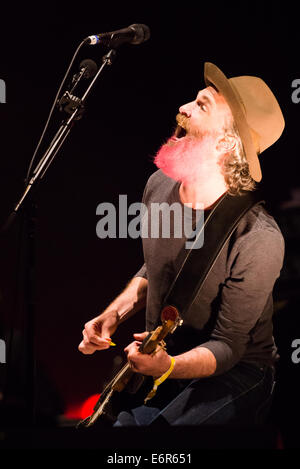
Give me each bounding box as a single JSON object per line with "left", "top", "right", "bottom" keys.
{"left": 164, "top": 191, "right": 263, "bottom": 315}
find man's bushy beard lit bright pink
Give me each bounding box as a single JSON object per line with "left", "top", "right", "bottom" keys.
{"left": 154, "top": 135, "right": 215, "bottom": 183}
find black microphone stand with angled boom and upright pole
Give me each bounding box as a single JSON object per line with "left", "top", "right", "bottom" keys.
{"left": 2, "top": 49, "right": 116, "bottom": 426}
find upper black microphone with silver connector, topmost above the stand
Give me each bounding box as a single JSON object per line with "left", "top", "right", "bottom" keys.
{"left": 84, "top": 24, "right": 150, "bottom": 48}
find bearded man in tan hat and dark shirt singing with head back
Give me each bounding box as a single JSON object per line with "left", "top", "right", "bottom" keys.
{"left": 79, "top": 63, "right": 284, "bottom": 426}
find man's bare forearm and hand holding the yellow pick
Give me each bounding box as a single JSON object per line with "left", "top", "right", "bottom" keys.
{"left": 78, "top": 277, "right": 148, "bottom": 354}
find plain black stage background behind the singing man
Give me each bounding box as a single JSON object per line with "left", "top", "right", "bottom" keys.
{"left": 0, "top": 1, "right": 300, "bottom": 446}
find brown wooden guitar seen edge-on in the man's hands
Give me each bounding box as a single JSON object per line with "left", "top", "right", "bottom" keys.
{"left": 77, "top": 306, "right": 182, "bottom": 428}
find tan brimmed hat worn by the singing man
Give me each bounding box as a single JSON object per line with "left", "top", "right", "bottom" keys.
{"left": 204, "top": 62, "right": 284, "bottom": 182}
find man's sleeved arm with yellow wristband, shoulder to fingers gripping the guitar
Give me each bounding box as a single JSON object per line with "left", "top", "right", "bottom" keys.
{"left": 125, "top": 225, "right": 284, "bottom": 378}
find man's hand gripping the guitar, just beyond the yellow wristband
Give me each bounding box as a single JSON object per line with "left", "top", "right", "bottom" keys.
{"left": 124, "top": 332, "right": 171, "bottom": 378}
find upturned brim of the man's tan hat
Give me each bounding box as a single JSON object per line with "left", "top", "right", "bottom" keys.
{"left": 204, "top": 62, "right": 262, "bottom": 182}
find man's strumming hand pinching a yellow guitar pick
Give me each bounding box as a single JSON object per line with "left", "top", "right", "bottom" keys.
{"left": 78, "top": 311, "right": 119, "bottom": 355}
